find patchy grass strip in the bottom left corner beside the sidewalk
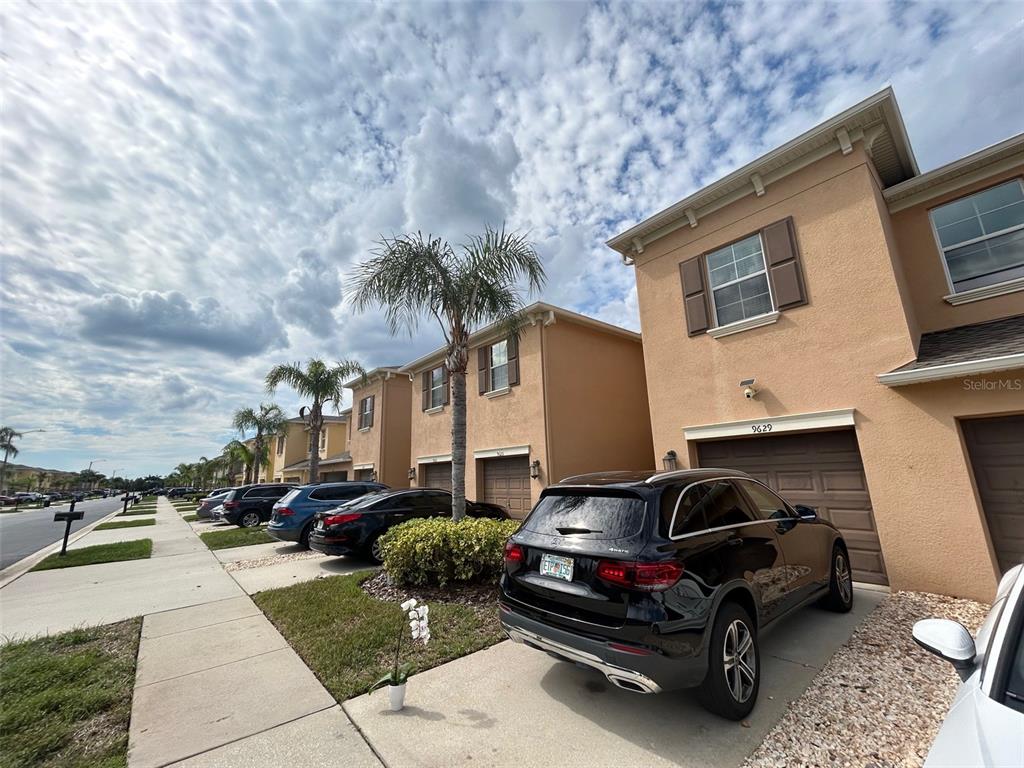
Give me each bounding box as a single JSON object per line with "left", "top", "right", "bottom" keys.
{"left": 0, "top": 618, "right": 142, "bottom": 768}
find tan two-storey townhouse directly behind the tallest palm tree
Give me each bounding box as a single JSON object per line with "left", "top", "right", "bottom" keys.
{"left": 401, "top": 303, "right": 654, "bottom": 517}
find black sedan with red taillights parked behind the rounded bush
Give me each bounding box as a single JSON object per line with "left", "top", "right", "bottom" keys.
{"left": 309, "top": 488, "right": 509, "bottom": 562}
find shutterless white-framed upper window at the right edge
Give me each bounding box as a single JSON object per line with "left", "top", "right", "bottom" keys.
{"left": 931, "top": 179, "right": 1024, "bottom": 294}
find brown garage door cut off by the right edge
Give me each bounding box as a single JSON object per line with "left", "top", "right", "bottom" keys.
{"left": 964, "top": 416, "right": 1024, "bottom": 571}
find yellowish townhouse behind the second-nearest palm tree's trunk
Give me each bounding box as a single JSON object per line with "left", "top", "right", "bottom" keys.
{"left": 261, "top": 411, "right": 352, "bottom": 484}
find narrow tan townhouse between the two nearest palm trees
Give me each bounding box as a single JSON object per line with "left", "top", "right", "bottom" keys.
{"left": 345, "top": 367, "right": 413, "bottom": 488}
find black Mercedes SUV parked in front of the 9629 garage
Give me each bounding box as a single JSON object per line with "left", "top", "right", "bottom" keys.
{"left": 500, "top": 469, "right": 853, "bottom": 720}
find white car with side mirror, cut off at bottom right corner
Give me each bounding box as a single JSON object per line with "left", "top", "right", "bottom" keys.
{"left": 913, "top": 564, "right": 1024, "bottom": 768}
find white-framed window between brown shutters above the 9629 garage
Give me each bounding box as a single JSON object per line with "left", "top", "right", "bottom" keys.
{"left": 708, "top": 234, "right": 774, "bottom": 326}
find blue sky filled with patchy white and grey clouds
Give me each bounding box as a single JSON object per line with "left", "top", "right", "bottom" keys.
{"left": 0, "top": 2, "right": 1024, "bottom": 481}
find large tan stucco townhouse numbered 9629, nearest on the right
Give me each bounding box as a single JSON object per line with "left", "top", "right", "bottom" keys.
{"left": 608, "top": 89, "right": 1024, "bottom": 600}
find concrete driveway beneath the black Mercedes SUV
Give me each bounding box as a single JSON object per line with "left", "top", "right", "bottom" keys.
{"left": 344, "top": 589, "right": 884, "bottom": 768}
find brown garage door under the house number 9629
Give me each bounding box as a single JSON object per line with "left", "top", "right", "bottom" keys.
{"left": 697, "top": 429, "right": 889, "bottom": 584}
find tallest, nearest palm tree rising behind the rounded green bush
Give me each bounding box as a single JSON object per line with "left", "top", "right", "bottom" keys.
{"left": 350, "top": 226, "right": 546, "bottom": 520}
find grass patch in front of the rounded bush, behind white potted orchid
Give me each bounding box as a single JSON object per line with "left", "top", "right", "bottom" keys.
{"left": 253, "top": 573, "right": 505, "bottom": 701}
